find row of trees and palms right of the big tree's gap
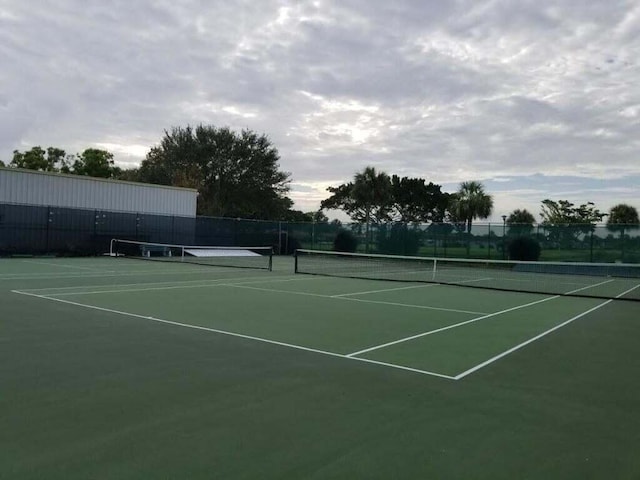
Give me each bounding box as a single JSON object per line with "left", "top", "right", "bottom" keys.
{"left": 321, "top": 167, "right": 639, "bottom": 233}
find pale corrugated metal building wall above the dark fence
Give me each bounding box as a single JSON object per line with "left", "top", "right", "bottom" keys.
{"left": 0, "top": 167, "right": 197, "bottom": 217}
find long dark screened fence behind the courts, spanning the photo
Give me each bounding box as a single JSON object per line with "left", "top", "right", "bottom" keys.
{"left": 0, "top": 204, "right": 640, "bottom": 263}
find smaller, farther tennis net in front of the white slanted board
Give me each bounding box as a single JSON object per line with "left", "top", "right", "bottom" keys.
{"left": 109, "top": 238, "right": 273, "bottom": 270}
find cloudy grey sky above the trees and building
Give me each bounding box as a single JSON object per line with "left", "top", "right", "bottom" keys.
{"left": 0, "top": 0, "right": 640, "bottom": 222}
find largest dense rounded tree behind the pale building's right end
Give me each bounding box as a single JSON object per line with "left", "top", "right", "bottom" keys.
{"left": 138, "top": 125, "right": 293, "bottom": 219}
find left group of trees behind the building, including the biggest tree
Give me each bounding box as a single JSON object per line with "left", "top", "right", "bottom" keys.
{"left": 0, "top": 125, "right": 310, "bottom": 222}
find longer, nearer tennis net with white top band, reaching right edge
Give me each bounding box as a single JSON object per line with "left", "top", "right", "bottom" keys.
{"left": 295, "top": 250, "right": 640, "bottom": 301}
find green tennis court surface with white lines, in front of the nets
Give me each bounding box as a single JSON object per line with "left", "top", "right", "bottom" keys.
{"left": 0, "top": 257, "right": 640, "bottom": 479}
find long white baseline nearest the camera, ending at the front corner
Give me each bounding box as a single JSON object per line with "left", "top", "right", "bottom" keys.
{"left": 11, "top": 290, "right": 455, "bottom": 380}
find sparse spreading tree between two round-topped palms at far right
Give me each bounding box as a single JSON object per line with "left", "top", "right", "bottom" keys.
{"left": 540, "top": 199, "right": 607, "bottom": 247}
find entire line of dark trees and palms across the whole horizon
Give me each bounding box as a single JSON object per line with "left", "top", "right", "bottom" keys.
{"left": 0, "top": 125, "right": 640, "bottom": 231}
